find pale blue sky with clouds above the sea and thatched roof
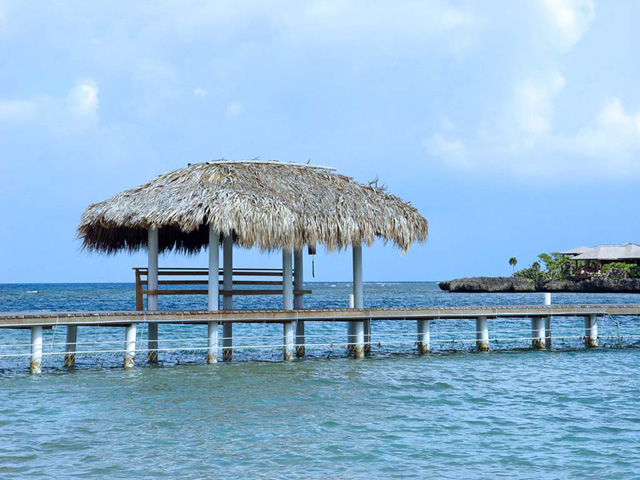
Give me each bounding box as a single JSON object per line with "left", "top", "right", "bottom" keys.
{"left": 0, "top": 0, "right": 640, "bottom": 282}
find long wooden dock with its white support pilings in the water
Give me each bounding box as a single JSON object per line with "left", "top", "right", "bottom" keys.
{"left": 5, "top": 305, "right": 640, "bottom": 373}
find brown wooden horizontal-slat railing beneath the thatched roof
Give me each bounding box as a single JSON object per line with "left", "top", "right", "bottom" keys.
{"left": 133, "top": 267, "right": 311, "bottom": 311}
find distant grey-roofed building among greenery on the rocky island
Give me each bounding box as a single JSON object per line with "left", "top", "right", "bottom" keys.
{"left": 560, "top": 243, "right": 640, "bottom": 278}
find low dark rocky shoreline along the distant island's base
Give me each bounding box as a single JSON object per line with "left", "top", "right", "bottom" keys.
{"left": 438, "top": 277, "right": 640, "bottom": 293}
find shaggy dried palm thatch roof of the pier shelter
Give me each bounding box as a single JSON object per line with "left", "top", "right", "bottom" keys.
{"left": 78, "top": 160, "right": 428, "bottom": 253}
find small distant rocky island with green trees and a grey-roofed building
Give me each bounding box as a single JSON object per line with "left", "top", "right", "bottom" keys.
{"left": 439, "top": 243, "right": 640, "bottom": 293}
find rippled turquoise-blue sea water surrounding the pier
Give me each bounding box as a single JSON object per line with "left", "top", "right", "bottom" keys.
{"left": 0, "top": 284, "right": 640, "bottom": 479}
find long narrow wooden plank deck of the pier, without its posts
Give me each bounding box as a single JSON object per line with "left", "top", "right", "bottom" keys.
{"left": 0, "top": 305, "right": 640, "bottom": 328}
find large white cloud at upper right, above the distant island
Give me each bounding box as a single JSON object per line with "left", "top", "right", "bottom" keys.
{"left": 423, "top": 0, "right": 640, "bottom": 179}
